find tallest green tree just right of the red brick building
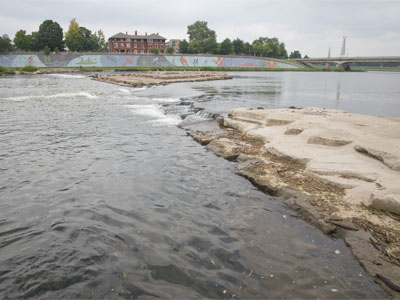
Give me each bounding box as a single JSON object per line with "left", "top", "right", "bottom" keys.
{"left": 187, "top": 21, "right": 217, "bottom": 53}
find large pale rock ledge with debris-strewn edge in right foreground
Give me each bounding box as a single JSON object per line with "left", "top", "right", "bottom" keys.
{"left": 186, "top": 108, "right": 400, "bottom": 298}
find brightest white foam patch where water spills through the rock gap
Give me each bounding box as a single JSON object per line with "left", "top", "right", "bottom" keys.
{"left": 126, "top": 104, "right": 181, "bottom": 125}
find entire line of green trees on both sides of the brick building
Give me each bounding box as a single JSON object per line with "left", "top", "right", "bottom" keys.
{"left": 0, "top": 19, "right": 307, "bottom": 59}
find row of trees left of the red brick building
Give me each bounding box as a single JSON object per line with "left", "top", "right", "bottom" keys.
{"left": 0, "top": 19, "right": 107, "bottom": 52}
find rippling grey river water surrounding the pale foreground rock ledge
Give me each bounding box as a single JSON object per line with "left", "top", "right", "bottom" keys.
{"left": 0, "top": 72, "right": 400, "bottom": 299}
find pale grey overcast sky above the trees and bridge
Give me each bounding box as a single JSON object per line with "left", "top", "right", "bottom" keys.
{"left": 0, "top": 0, "right": 400, "bottom": 57}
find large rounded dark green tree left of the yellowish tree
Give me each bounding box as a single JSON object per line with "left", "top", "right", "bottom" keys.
{"left": 38, "top": 20, "right": 64, "bottom": 51}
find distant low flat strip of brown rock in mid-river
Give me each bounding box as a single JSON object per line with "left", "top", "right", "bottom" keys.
{"left": 92, "top": 71, "right": 232, "bottom": 87}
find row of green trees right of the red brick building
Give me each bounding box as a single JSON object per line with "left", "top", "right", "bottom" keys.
{"left": 179, "top": 21, "right": 301, "bottom": 58}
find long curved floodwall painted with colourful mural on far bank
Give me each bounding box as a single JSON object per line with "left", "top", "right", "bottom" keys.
{"left": 0, "top": 54, "right": 298, "bottom": 69}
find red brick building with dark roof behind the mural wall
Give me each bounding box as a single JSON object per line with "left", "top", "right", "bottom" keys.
{"left": 108, "top": 31, "right": 166, "bottom": 54}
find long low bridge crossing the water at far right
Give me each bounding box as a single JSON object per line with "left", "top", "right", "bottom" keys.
{"left": 294, "top": 56, "right": 400, "bottom": 69}
